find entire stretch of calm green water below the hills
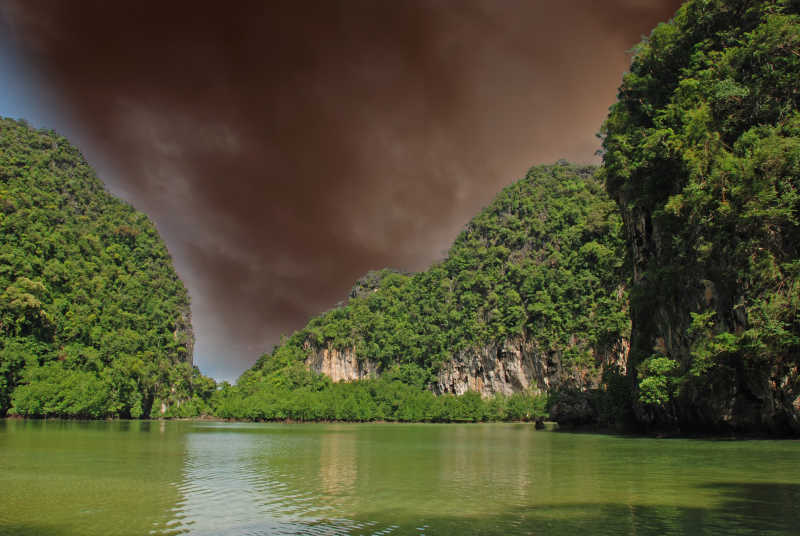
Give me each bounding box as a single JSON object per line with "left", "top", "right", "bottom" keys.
{"left": 0, "top": 421, "right": 800, "bottom": 536}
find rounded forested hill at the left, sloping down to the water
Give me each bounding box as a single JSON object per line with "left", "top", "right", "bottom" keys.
{"left": 0, "top": 119, "right": 214, "bottom": 417}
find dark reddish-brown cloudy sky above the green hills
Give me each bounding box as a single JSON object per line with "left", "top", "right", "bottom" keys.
{"left": 0, "top": 0, "right": 681, "bottom": 381}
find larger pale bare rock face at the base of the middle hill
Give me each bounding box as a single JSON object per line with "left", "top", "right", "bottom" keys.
{"left": 434, "top": 337, "right": 628, "bottom": 396}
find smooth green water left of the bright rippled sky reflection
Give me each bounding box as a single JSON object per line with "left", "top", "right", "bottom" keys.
{"left": 0, "top": 420, "right": 185, "bottom": 536}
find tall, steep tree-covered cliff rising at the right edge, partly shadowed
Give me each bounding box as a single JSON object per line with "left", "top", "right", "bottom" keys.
{"left": 603, "top": 0, "right": 800, "bottom": 431}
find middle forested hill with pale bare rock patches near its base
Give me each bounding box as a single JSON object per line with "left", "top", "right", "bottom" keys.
{"left": 214, "top": 162, "right": 629, "bottom": 419}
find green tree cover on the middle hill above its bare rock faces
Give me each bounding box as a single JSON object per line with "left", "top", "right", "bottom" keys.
{"left": 294, "top": 163, "right": 627, "bottom": 372}
